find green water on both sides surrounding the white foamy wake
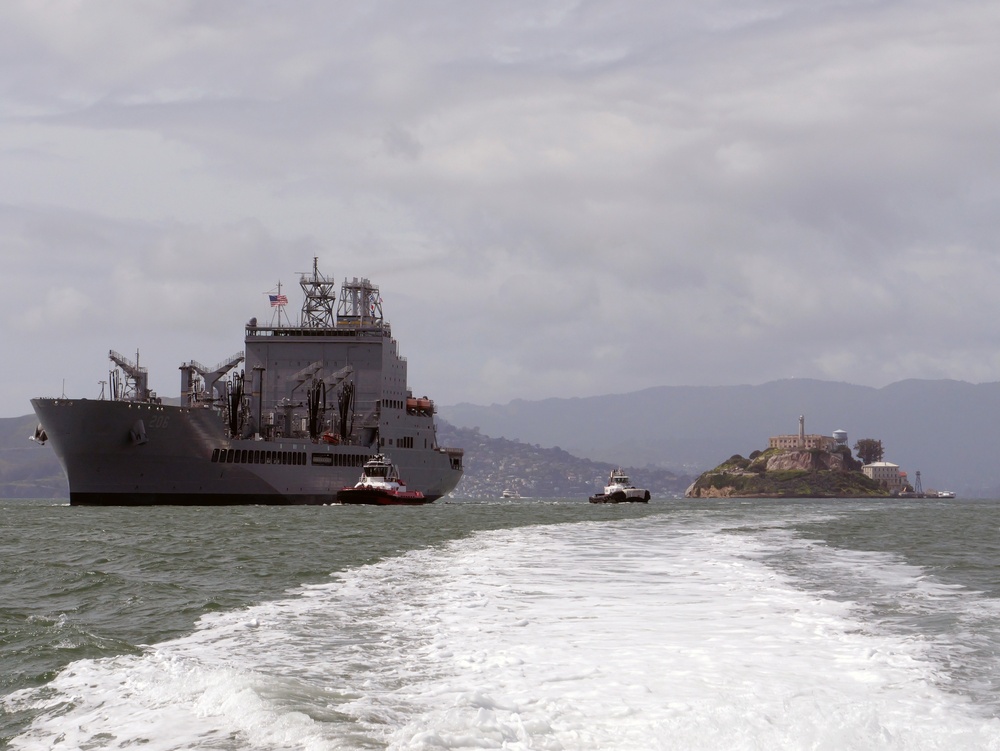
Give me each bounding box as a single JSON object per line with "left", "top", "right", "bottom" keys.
{"left": 0, "top": 499, "right": 1000, "bottom": 748}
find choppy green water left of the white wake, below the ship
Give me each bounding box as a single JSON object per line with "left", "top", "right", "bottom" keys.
{"left": 0, "top": 500, "right": 652, "bottom": 692}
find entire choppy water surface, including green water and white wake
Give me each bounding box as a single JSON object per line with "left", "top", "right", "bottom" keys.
{"left": 0, "top": 499, "right": 1000, "bottom": 751}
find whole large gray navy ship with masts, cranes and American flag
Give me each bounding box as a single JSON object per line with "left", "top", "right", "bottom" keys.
{"left": 31, "top": 259, "right": 463, "bottom": 506}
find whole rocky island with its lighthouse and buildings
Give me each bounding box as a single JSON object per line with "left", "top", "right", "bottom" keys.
{"left": 685, "top": 415, "right": 950, "bottom": 498}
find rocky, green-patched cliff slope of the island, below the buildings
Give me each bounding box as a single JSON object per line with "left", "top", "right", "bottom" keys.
{"left": 685, "top": 447, "right": 889, "bottom": 498}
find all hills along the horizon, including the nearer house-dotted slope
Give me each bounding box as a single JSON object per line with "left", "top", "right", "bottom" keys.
{"left": 7, "top": 379, "right": 1000, "bottom": 498}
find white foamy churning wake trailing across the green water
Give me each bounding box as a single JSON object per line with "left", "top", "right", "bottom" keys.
{"left": 3, "top": 509, "right": 1000, "bottom": 751}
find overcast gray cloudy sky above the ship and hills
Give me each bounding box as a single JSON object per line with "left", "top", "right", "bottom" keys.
{"left": 0, "top": 0, "right": 1000, "bottom": 416}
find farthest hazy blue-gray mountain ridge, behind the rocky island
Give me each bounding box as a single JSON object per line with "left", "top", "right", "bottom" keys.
{"left": 438, "top": 379, "right": 1000, "bottom": 498}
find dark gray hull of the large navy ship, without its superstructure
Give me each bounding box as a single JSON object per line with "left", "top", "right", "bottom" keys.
{"left": 32, "top": 399, "right": 462, "bottom": 506}
